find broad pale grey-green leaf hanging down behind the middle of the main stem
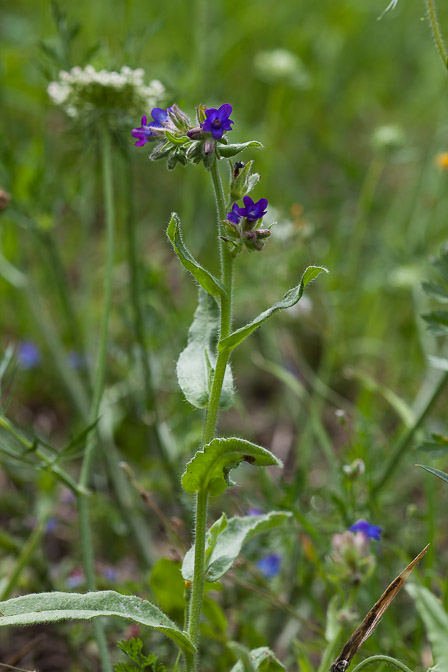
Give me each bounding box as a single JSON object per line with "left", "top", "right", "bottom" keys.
{"left": 177, "top": 289, "right": 234, "bottom": 409}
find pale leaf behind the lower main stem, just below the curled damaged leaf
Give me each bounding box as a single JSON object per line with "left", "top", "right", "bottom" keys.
{"left": 182, "top": 511, "right": 292, "bottom": 582}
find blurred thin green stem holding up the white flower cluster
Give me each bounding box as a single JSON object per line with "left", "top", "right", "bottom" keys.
{"left": 78, "top": 127, "right": 115, "bottom": 672}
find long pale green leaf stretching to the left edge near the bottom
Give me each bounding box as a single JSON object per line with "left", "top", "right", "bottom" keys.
{"left": 0, "top": 590, "right": 195, "bottom": 654}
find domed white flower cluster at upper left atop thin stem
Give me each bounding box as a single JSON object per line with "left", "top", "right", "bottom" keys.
{"left": 47, "top": 65, "right": 165, "bottom": 117}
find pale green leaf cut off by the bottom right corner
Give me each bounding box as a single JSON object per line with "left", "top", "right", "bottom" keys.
{"left": 406, "top": 583, "right": 448, "bottom": 671}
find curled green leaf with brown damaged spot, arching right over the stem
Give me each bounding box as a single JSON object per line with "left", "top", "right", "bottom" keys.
{"left": 182, "top": 437, "right": 283, "bottom": 496}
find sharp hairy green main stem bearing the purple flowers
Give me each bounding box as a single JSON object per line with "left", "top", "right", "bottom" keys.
{"left": 186, "top": 162, "right": 233, "bottom": 671}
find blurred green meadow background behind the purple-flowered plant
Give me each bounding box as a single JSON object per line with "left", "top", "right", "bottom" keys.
{"left": 0, "top": 0, "right": 448, "bottom": 672}
